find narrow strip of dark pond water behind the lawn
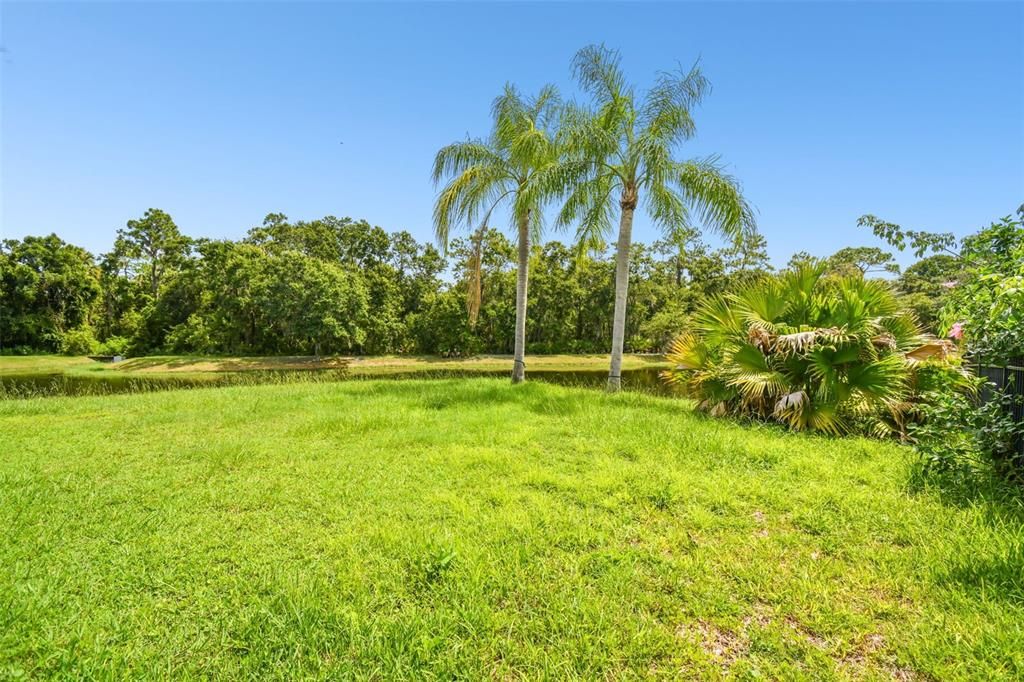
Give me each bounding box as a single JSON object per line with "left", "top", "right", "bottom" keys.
{"left": 0, "top": 368, "right": 670, "bottom": 399}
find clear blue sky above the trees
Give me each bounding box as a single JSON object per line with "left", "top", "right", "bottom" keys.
{"left": 0, "top": 1, "right": 1024, "bottom": 264}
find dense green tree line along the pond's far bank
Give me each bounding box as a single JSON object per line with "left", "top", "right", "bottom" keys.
{"left": 0, "top": 209, "right": 769, "bottom": 355}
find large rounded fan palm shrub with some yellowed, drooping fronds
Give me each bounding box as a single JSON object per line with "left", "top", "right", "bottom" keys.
{"left": 663, "top": 263, "right": 950, "bottom": 436}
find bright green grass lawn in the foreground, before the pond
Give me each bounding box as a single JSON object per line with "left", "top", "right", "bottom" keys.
{"left": 0, "top": 379, "right": 1024, "bottom": 680}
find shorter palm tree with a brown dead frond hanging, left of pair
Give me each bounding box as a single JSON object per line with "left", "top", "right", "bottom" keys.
{"left": 433, "top": 85, "right": 570, "bottom": 383}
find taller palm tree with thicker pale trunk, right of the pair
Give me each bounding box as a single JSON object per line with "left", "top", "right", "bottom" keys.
{"left": 558, "top": 45, "right": 755, "bottom": 391}
